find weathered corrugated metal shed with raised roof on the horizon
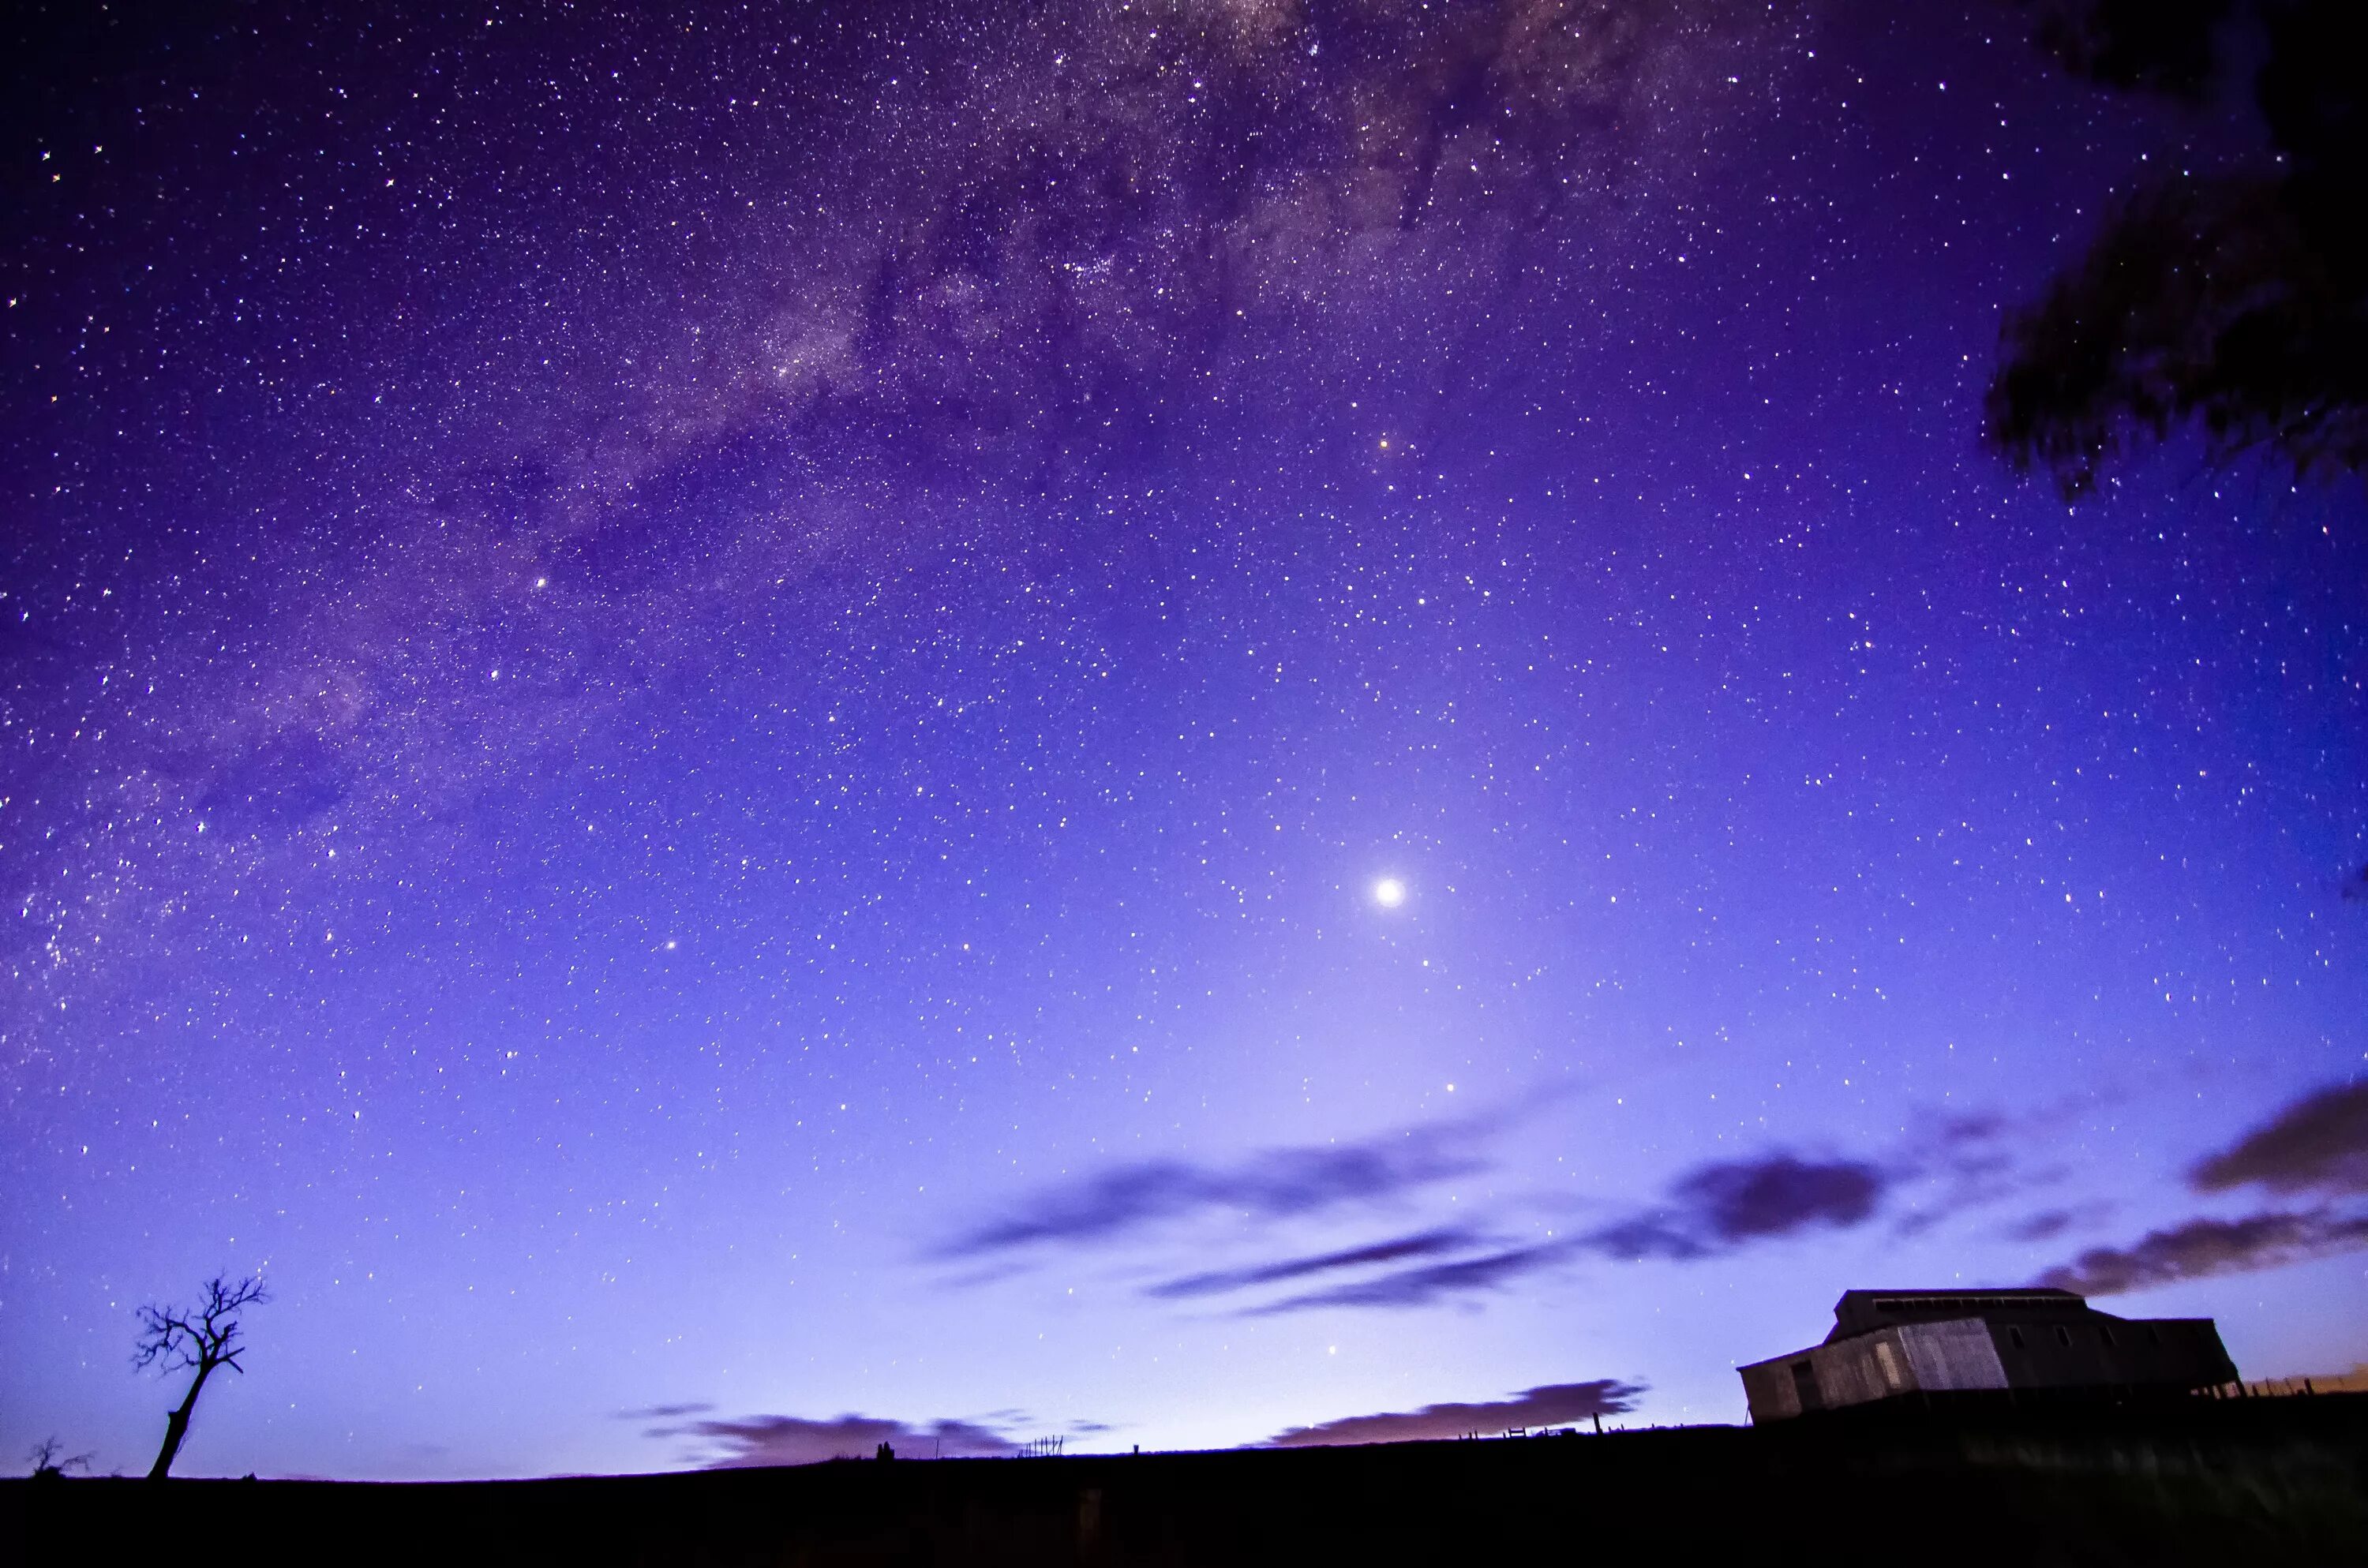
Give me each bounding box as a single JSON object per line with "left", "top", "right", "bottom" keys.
{"left": 1738, "top": 1289, "right": 2235, "bottom": 1424}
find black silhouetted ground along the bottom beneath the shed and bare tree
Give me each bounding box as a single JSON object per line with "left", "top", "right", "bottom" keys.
{"left": 0, "top": 1395, "right": 2368, "bottom": 1568}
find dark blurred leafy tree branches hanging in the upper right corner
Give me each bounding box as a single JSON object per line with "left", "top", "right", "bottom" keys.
{"left": 1984, "top": 0, "right": 2368, "bottom": 497}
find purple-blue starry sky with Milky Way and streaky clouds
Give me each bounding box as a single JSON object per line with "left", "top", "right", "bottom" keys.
{"left": 0, "top": 0, "right": 2368, "bottom": 1478}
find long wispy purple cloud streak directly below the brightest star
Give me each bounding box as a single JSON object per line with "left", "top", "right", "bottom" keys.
{"left": 935, "top": 1123, "right": 1482, "bottom": 1258}
